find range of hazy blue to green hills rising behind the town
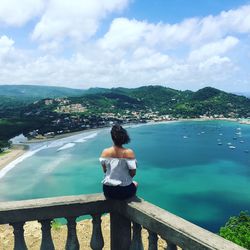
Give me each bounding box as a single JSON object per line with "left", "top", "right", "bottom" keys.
{"left": 0, "top": 85, "right": 250, "bottom": 117}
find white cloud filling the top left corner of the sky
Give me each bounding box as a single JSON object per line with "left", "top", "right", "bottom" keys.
{"left": 0, "top": 0, "right": 46, "bottom": 26}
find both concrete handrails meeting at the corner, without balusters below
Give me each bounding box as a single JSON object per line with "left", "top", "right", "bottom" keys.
{"left": 0, "top": 194, "right": 245, "bottom": 250}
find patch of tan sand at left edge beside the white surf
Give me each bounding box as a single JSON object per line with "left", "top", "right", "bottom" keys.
{"left": 0, "top": 145, "right": 28, "bottom": 170}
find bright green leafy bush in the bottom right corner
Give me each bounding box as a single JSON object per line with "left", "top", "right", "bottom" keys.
{"left": 219, "top": 211, "right": 250, "bottom": 249}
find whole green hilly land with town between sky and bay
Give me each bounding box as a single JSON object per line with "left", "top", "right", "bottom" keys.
{"left": 0, "top": 85, "right": 250, "bottom": 150}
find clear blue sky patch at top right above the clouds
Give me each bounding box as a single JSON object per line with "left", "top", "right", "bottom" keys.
{"left": 126, "top": 0, "right": 249, "bottom": 24}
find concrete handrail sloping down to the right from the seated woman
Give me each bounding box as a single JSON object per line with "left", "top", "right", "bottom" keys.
{"left": 121, "top": 199, "right": 245, "bottom": 250}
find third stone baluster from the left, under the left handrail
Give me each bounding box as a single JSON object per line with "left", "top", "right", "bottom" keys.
{"left": 66, "top": 217, "right": 79, "bottom": 250}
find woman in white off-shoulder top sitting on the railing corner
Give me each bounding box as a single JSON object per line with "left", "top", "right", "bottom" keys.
{"left": 100, "top": 125, "right": 138, "bottom": 200}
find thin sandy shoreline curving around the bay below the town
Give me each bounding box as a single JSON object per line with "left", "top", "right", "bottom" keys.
{"left": 0, "top": 118, "right": 244, "bottom": 177}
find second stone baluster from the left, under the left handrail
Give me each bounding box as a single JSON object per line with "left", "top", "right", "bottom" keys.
{"left": 39, "top": 220, "right": 55, "bottom": 250}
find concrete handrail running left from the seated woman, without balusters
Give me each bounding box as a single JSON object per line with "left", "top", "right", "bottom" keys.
{"left": 0, "top": 194, "right": 112, "bottom": 224}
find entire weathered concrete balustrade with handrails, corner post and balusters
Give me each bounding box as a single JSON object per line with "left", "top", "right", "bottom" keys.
{"left": 0, "top": 194, "right": 244, "bottom": 250}
